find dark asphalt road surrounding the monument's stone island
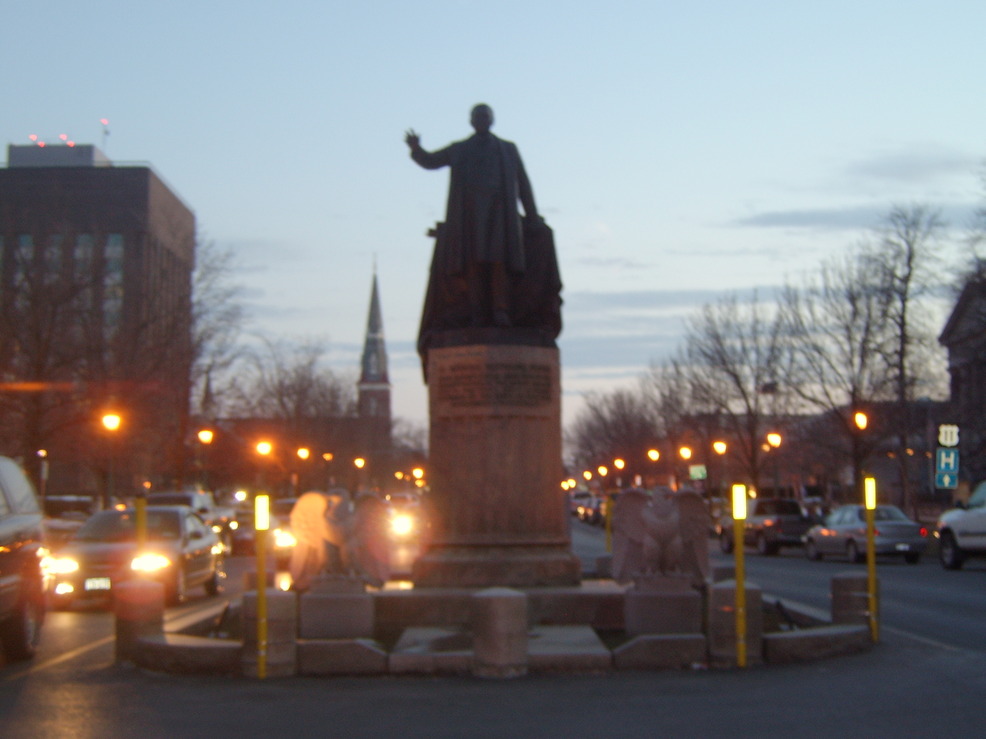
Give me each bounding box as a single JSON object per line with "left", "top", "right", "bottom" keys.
{"left": 0, "top": 524, "right": 986, "bottom": 739}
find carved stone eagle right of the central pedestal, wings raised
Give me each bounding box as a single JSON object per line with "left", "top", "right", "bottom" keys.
{"left": 613, "top": 488, "right": 709, "bottom": 585}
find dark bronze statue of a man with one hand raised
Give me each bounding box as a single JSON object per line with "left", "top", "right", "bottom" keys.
{"left": 404, "top": 104, "right": 544, "bottom": 327}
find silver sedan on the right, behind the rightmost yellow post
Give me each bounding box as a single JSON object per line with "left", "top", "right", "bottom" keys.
{"left": 805, "top": 505, "right": 928, "bottom": 564}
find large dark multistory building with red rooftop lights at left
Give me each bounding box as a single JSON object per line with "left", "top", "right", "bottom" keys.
{"left": 0, "top": 145, "right": 195, "bottom": 494}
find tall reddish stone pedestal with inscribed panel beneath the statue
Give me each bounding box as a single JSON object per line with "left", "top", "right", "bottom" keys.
{"left": 413, "top": 344, "right": 581, "bottom": 587}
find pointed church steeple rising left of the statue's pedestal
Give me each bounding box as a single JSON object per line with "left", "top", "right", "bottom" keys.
{"left": 357, "top": 269, "right": 391, "bottom": 450}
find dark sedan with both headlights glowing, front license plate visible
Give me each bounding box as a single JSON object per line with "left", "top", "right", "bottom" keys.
{"left": 50, "top": 506, "right": 225, "bottom": 608}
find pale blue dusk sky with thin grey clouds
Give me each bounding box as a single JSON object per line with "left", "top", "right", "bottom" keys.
{"left": 0, "top": 0, "right": 986, "bottom": 424}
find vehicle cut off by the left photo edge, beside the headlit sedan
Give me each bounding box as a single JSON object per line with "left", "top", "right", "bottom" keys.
{"left": 0, "top": 457, "right": 47, "bottom": 661}
